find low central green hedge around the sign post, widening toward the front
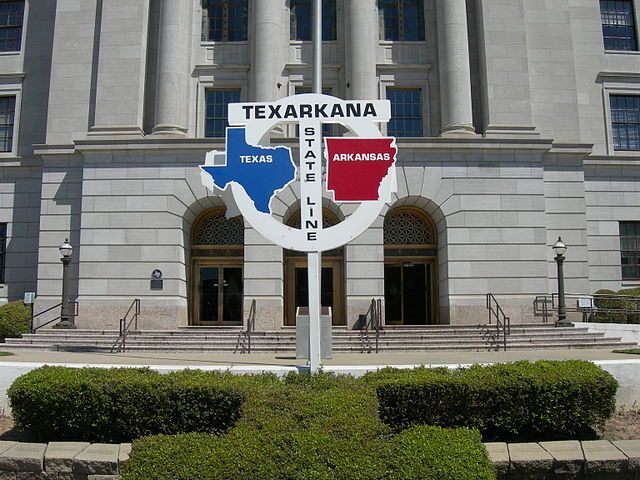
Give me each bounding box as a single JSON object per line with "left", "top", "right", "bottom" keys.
{"left": 121, "top": 374, "right": 495, "bottom": 480}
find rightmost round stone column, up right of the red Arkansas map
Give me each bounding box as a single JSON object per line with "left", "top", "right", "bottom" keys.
{"left": 437, "top": 0, "right": 475, "bottom": 136}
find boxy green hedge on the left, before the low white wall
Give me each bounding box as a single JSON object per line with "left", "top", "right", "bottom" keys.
{"left": 7, "top": 367, "right": 277, "bottom": 442}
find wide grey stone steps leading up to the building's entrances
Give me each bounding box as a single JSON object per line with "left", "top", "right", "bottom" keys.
{"left": 0, "top": 324, "right": 637, "bottom": 353}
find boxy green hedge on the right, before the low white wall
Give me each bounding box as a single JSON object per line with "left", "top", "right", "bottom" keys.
{"left": 365, "top": 360, "right": 618, "bottom": 441}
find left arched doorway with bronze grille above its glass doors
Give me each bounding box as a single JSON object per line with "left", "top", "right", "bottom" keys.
{"left": 191, "top": 208, "right": 244, "bottom": 327}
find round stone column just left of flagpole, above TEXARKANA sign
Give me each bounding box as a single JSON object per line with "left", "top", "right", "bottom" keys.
{"left": 251, "top": 0, "right": 288, "bottom": 102}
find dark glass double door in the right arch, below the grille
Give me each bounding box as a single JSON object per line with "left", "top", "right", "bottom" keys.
{"left": 384, "top": 262, "right": 435, "bottom": 325}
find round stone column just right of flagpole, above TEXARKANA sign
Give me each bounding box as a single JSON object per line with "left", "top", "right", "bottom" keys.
{"left": 345, "top": 0, "right": 379, "bottom": 100}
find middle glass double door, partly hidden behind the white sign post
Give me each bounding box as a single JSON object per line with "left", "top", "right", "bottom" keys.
{"left": 285, "top": 258, "right": 344, "bottom": 326}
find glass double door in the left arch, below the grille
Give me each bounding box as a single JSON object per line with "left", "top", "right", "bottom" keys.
{"left": 193, "top": 263, "right": 243, "bottom": 326}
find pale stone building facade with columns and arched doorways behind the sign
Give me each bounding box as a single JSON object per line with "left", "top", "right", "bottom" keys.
{"left": 0, "top": 0, "right": 640, "bottom": 330}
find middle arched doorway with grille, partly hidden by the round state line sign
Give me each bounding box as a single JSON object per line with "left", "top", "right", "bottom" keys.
{"left": 284, "top": 208, "right": 345, "bottom": 326}
